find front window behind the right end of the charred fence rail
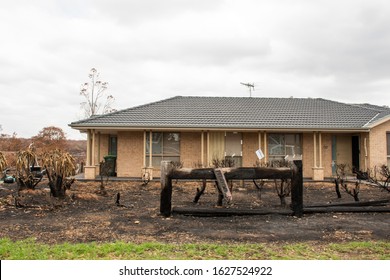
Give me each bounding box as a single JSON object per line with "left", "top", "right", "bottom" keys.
{"left": 268, "top": 133, "right": 302, "bottom": 161}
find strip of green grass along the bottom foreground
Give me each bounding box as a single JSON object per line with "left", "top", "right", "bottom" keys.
{"left": 0, "top": 238, "right": 390, "bottom": 260}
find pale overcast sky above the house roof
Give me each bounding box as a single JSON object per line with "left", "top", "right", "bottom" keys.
{"left": 0, "top": 0, "right": 390, "bottom": 139}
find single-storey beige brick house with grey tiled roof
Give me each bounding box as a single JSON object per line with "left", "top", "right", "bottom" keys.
{"left": 70, "top": 96, "right": 390, "bottom": 180}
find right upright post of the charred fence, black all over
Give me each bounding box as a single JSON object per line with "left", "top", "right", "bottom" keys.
{"left": 291, "top": 160, "right": 303, "bottom": 217}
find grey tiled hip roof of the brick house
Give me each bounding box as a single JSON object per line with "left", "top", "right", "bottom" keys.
{"left": 70, "top": 96, "right": 390, "bottom": 129}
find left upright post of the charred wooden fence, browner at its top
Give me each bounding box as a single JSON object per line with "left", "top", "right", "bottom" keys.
{"left": 160, "top": 161, "right": 173, "bottom": 217}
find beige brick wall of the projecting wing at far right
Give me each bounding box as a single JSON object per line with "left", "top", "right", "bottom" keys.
{"left": 368, "top": 121, "right": 390, "bottom": 168}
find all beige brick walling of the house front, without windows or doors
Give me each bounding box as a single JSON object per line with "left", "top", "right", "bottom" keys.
{"left": 95, "top": 129, "right": 390, "bottom": 178}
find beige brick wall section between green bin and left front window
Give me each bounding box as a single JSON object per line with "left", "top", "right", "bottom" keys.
{"left": 117, "top": 131, "right": 144, "bottom": 178}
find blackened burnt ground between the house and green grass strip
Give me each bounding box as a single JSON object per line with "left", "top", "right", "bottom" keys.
{"left": 0, "top": 178, "right": 390, "bottom": 244}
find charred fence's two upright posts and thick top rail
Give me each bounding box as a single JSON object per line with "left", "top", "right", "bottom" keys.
{"left": 160, "top": 160, "right": 303, "bottom": 217}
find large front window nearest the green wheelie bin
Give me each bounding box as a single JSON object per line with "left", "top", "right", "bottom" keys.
{"left": 145, "top": 132, "right": 180, "bottom": 167}
